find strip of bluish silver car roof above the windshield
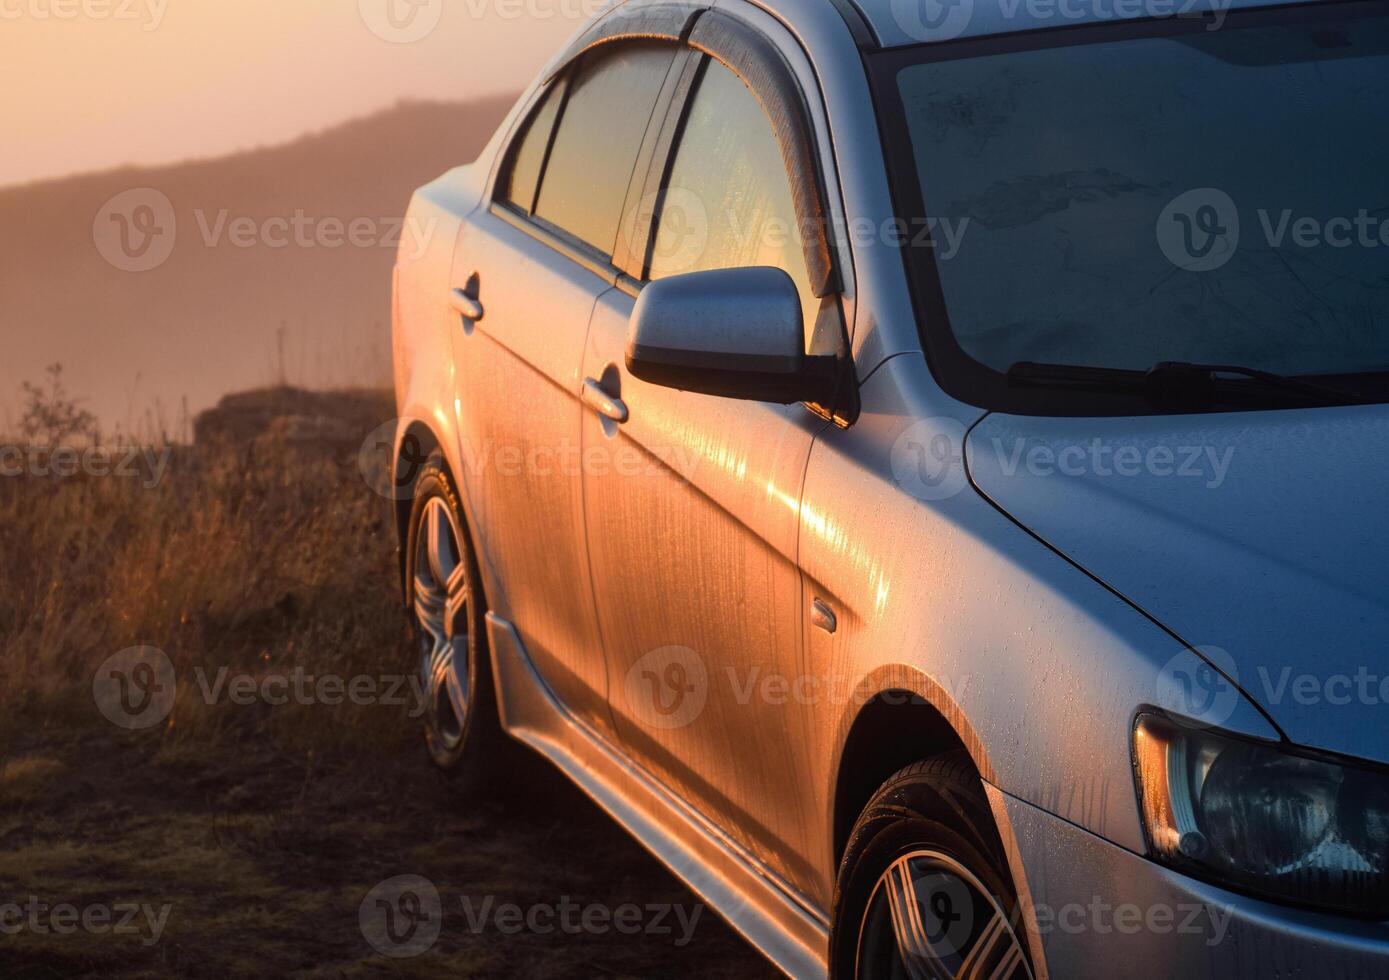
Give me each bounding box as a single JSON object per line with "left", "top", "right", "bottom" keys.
{"left": 833, "top": 0, "right": 1335, "bottom": 47}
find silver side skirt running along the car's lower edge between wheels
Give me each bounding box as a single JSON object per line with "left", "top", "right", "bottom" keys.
{"left": 488, "top": 614, "right": 829, "bottom": 977}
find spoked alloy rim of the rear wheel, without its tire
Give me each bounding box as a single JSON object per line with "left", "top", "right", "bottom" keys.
{"left": 414, "top": 498, "right": 469, "bottom": 751}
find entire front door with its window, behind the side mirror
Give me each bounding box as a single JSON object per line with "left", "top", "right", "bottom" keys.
{"left": 583, "top": 40, "right": 843, "bottom": 891}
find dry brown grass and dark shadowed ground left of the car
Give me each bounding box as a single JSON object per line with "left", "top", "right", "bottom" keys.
{"left": 0, "top": 385, "right": 770, "bottom": 980}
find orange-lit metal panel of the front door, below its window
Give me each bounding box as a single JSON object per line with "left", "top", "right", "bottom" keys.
{"left": 583, "top": 283, "right": 825, "bottom": 888}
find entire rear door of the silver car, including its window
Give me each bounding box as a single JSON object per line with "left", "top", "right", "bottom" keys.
{"left": 451, "top": 43, "right": 675, "bottom": 732}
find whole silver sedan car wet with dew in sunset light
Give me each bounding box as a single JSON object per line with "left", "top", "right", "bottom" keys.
{"left": 394, "top": 0, "right": 1389, "bottom": 980}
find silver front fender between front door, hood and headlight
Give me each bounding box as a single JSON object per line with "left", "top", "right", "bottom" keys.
{"left": 800, "top": 355, "right": 1278, "bottom": 888}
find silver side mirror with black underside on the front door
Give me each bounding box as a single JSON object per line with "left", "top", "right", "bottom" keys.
{"left": 626, "top": 268, "right": 838, "bottom": 405}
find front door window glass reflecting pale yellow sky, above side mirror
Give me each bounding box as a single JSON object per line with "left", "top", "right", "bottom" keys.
{"left": 649, "top": 61, "right": 839, "bottom": 354}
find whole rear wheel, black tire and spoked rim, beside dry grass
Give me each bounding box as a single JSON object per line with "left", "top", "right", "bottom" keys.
{"left": 406, "top": 453, "right": 508, "bottom": 786}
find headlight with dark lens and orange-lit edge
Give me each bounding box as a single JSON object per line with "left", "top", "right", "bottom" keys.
{"left": 1133, "top": 705, "right": 1389, "bottom": 918}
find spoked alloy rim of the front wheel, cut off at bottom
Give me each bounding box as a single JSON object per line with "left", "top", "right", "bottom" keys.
{"left": 856, "top": 851, "right": 1032, "bottom": 980}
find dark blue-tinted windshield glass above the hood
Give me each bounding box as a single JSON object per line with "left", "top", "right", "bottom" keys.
{"left": 878, "top": 6, "right": 1389, "bottom": 404}
